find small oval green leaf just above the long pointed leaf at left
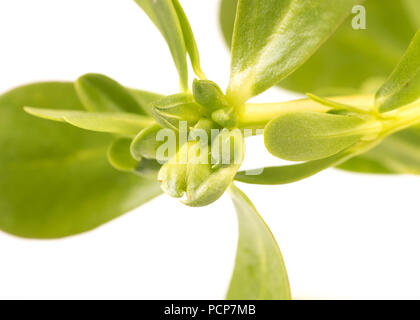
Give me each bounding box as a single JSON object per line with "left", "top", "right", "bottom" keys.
{"left": 75, "top": 74, "right": 147, "bottom": 115}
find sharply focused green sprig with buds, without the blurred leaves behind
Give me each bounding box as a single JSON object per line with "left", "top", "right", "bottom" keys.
{"left": 0, "top": 0, "right": 420, "bottom": 299}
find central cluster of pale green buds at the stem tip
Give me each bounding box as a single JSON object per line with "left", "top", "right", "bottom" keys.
{"left": 131, "top": 80, "right": 245, "bottom": 206}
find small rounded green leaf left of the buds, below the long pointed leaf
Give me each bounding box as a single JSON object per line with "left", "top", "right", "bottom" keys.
{"left": 108, "top": 138, "right": 138, "bottom": 171}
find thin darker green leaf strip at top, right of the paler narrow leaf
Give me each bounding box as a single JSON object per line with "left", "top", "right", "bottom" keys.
{"left": 172, "top": 0, "right": 206, "bottom": 79}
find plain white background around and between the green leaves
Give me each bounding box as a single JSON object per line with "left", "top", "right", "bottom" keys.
{"left": 0, "top": 0, "right": 420, "bottom": 299}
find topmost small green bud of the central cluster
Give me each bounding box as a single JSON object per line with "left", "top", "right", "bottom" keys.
{"left": 193, "top": 80, "right": 229, "bottom": 111}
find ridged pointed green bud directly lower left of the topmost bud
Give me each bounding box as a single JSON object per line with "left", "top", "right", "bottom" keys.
{"left": 152, "top": 93, "right": 207, "bottom": 130}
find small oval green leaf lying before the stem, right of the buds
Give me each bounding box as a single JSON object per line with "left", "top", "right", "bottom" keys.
{"left": 264, "top": 112, "right": 366, "bottom": 161}
